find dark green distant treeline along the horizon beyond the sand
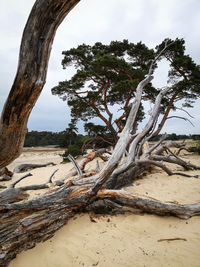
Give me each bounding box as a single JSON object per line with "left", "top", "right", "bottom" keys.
{"left": 24, "top": 129, "right": 200, "bottom": 147}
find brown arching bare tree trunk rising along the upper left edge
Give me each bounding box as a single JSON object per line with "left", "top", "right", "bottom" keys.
{"left": 0, "top": 0, "right": 80, "bottom": 168}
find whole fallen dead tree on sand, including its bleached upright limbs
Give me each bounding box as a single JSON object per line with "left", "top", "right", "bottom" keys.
{"left": 0, "top": 42, "right": 200, "bottom": 266}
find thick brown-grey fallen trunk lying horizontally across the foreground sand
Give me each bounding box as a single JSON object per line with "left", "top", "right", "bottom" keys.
{"left": 0, "top": 186, "right": 200, "bottom": 266}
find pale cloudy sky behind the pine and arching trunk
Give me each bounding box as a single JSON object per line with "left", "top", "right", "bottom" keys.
{"left": 0, "top": 0, "right": 200, "bottom": 134}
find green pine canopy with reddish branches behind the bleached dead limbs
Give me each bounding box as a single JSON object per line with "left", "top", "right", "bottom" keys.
{"left": 52, "top": 39, "right": 200, "bottom": 143}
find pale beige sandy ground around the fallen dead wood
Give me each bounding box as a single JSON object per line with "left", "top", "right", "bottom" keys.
{"left": 2, "top": 148, "right": 200, "bottom": 267}
